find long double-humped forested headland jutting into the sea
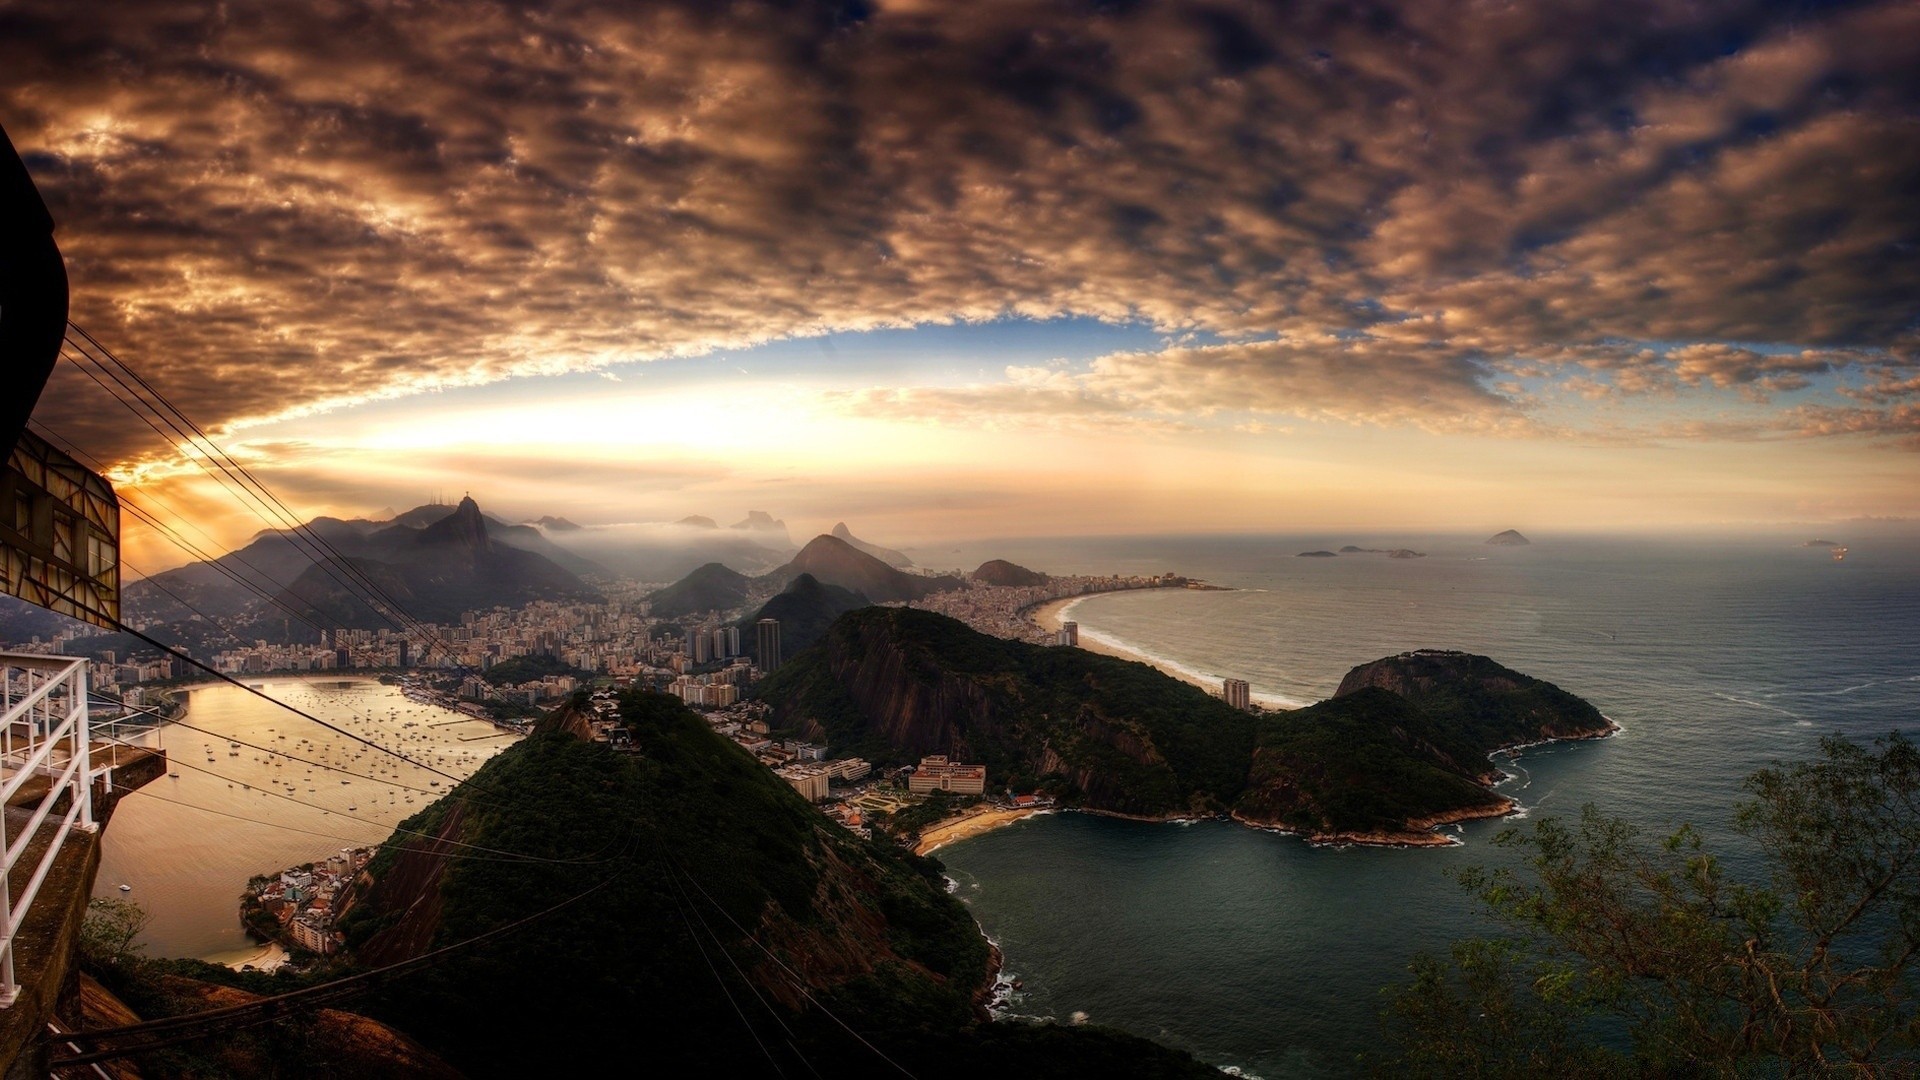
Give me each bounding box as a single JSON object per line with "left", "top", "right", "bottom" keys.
{"left": 756, "top": 607, "right": 1613, "bottom": 844}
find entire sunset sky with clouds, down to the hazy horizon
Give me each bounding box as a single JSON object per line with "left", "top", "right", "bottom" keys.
{"left": 0, "top": 0, "right": 1920, "bottom": 575}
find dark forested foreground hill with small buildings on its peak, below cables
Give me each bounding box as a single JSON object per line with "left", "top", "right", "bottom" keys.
{"left": 344, "top": 694, "right": 1217, "bottom": 1080}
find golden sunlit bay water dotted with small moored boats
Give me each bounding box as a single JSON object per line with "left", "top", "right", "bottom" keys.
{"left": 94, "top": 678, "right": 511, "bottom": 963}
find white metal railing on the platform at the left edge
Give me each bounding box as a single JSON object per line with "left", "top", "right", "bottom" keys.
{"left": 0, "top": 653, "right": 98, "bottom": 1009}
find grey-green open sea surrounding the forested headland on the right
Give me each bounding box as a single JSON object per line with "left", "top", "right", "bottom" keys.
{"left": 916, "top": 534, "right": 1920, "bottom": 1080}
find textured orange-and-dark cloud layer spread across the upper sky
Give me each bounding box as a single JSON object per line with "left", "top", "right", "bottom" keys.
{"left": 0, "top": 0, "right": 1920, "bottom": 455}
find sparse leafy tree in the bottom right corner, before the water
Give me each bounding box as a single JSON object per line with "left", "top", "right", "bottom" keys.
{"left": 1382, "top": 734, "right": 1920, "bottom": 1076}
